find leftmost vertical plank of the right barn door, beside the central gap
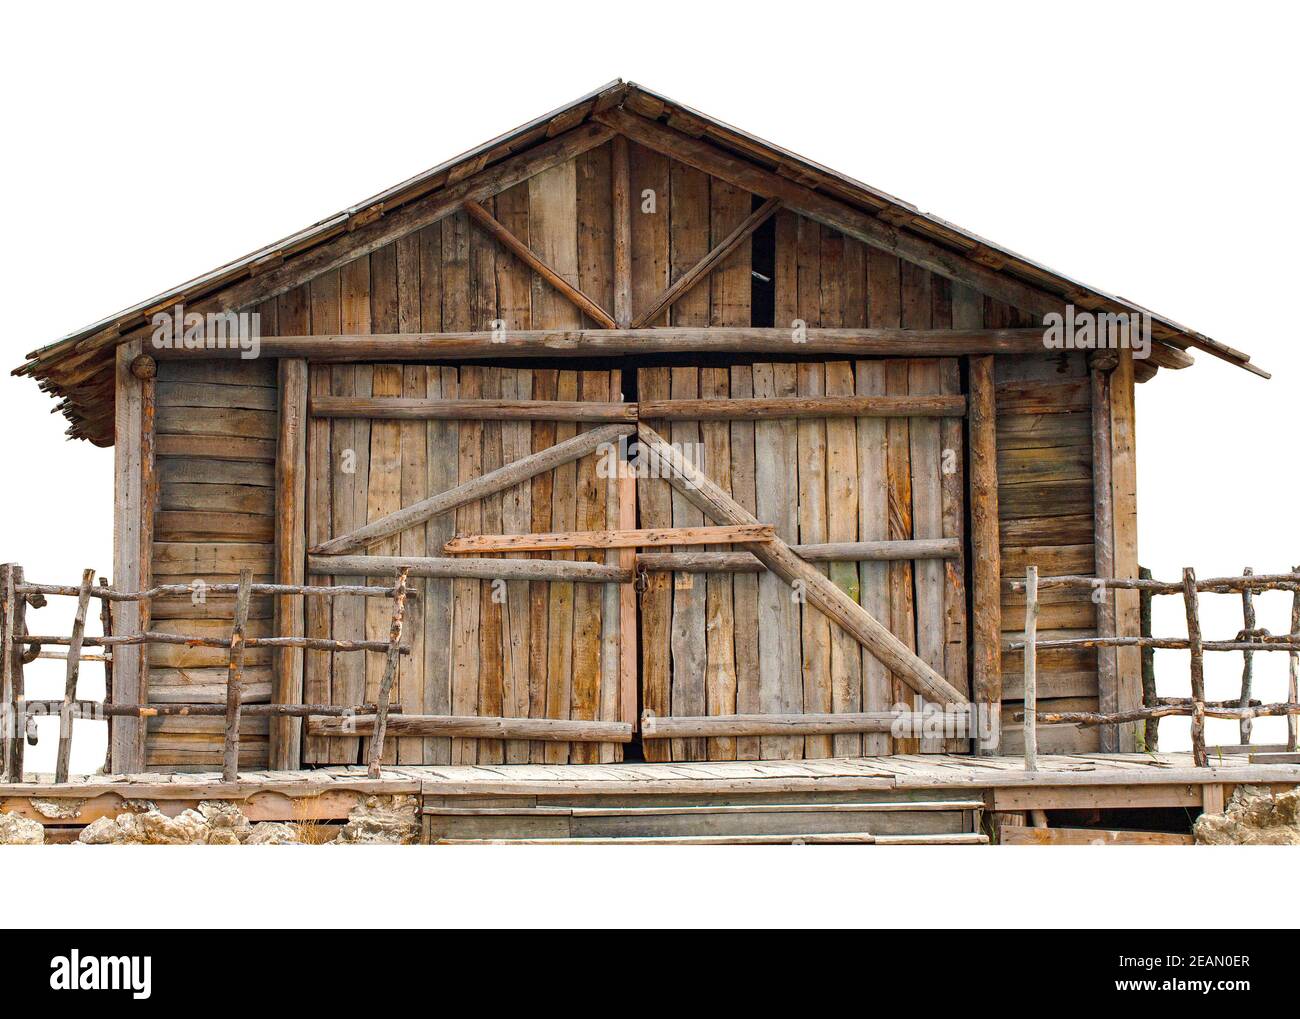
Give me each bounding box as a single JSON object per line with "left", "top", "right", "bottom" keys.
{"left": 637, "top": 368, "right": 672, "bottom": 762}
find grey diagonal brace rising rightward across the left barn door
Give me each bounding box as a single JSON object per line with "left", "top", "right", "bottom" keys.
{"left": 308, "top": 425, "right": 636, "bottom": 553}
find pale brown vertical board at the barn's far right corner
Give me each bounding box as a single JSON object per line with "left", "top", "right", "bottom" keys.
{"left": 1110, "top": 350, "right": 1141, "bottom": 754}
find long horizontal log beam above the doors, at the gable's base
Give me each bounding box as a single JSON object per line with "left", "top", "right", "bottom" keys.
{"left": 153, "top": 326, "right": 1044, "bottom": 363}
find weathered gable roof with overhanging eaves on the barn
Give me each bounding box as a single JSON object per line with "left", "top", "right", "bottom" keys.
{"left": 13, "top": 81, "right": 1269, "bottom": 445}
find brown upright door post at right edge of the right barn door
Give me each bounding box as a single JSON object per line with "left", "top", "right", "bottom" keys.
{"left": 967, "top": 355, "right": 1002, "bottom": 754}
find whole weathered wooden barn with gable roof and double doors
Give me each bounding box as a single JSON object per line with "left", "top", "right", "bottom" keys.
{"left": 17, "top": 82, "right": 1295, "bottom": 838}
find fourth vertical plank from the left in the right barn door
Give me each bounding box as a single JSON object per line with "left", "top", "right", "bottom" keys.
{"left": 731, "top": 364, "right": 762, "bottom": 760}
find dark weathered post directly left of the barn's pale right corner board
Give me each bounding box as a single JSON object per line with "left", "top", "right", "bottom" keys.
{"left": 1091, "top": 361, "right": 1119, "bottom": 754}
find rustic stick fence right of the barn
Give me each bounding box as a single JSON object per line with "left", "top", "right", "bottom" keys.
{"left": 1006, "top": 565, "right": 1300, "bottom": 771}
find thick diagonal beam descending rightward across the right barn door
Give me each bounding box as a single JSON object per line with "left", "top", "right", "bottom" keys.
{"left": 637, "top": 424, "right": 966, "bottom": 706}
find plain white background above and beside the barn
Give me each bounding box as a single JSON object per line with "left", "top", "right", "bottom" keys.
{"left": 0, "top": 0, "right": 1300, "bottom": 924}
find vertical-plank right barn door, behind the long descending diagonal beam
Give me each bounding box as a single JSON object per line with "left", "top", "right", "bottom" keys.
{"left": 637, "top": 359, "right": 969, "bottom": 760}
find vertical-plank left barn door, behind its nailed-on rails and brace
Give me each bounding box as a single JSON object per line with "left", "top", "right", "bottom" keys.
{"left": 304, "top": 364, "right": 636, "bottom": 764}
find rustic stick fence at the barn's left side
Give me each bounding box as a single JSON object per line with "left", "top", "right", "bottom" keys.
{"left": 0, "top": 564, "right": 413, "bottom": 782}
